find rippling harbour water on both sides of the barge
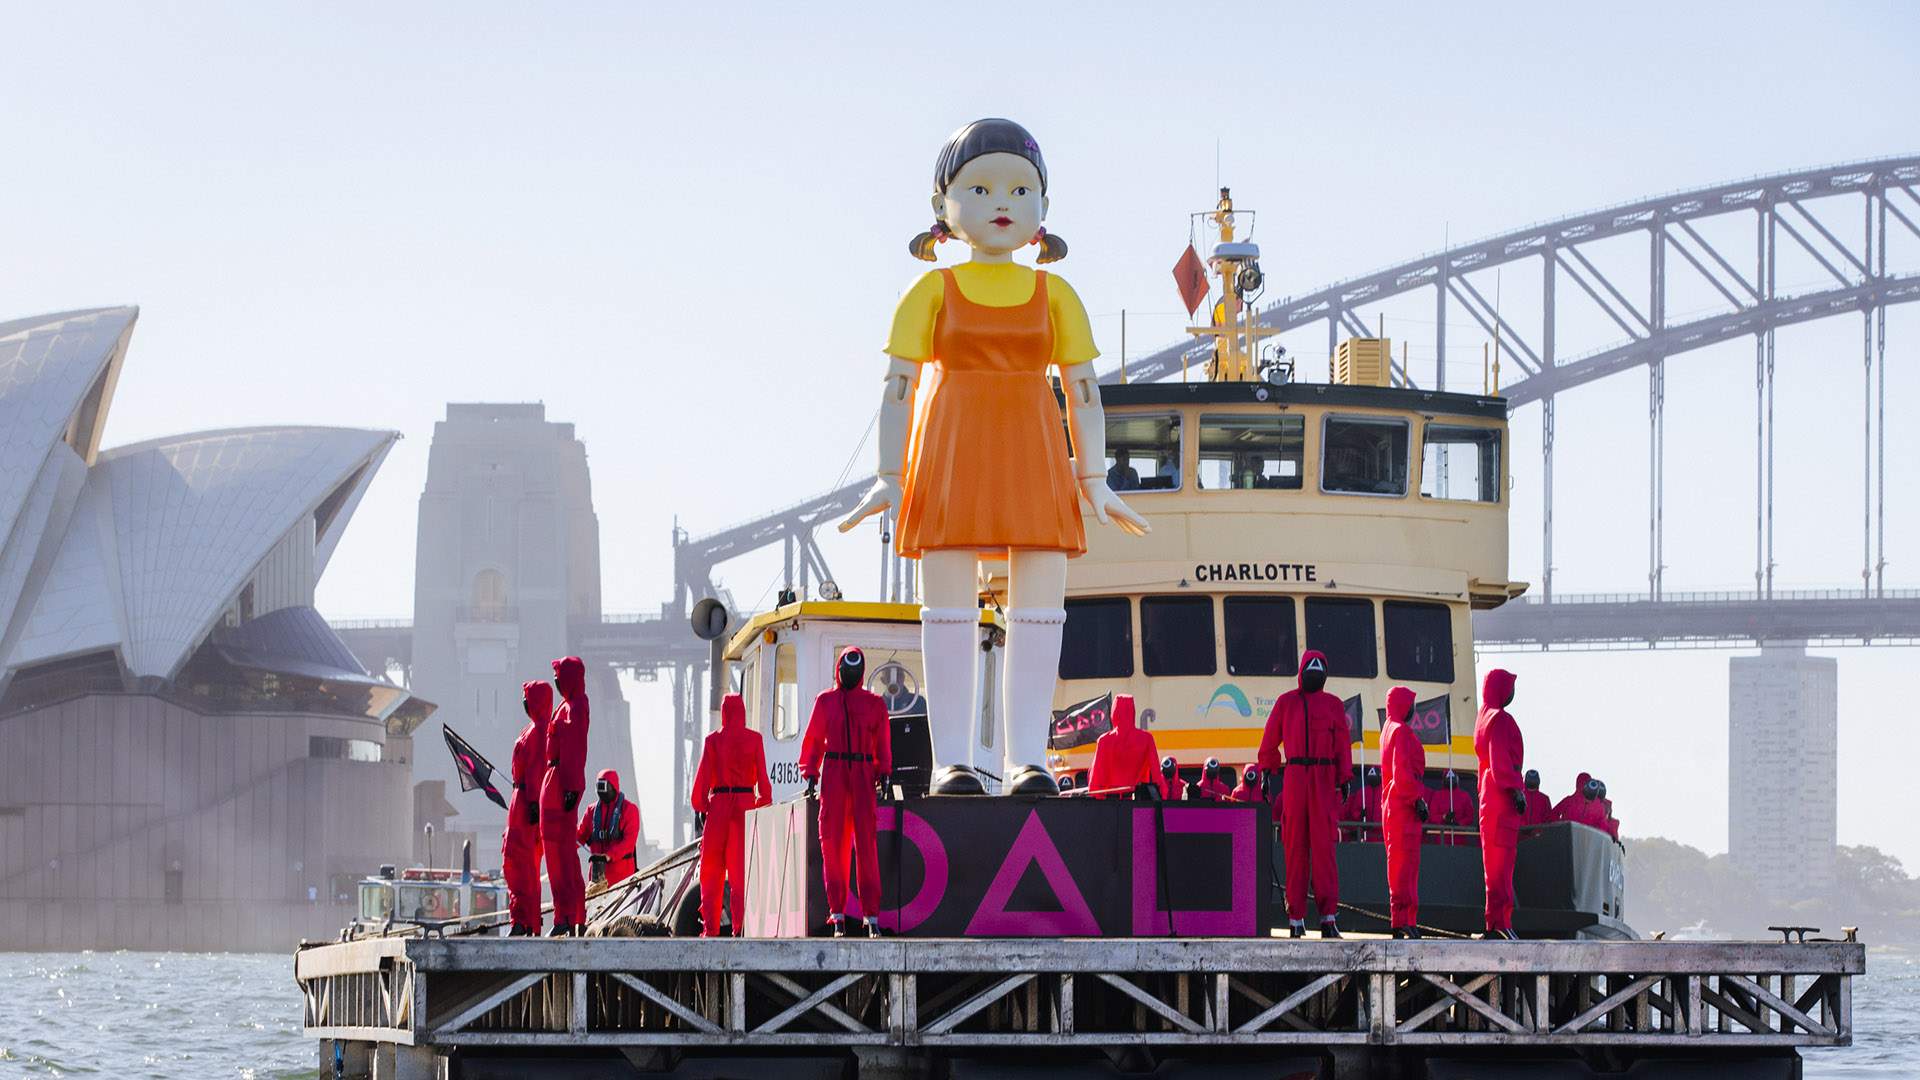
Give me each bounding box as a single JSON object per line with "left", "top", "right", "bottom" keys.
{"left": 0, "top": 951, "right": 1920, "bottom": 1080}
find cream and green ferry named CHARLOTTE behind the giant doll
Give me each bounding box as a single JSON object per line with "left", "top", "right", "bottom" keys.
{"left": 1048, "top": 188, "right": 1630, "bottom": 936}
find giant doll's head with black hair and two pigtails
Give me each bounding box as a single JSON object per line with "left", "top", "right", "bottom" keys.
{"left": 906, "top": 119, "right": 1068, "bottom": 263}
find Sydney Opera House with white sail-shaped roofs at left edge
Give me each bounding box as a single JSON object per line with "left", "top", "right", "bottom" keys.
{"left": 0, "top": 307, "right": 432, "bottom": 949}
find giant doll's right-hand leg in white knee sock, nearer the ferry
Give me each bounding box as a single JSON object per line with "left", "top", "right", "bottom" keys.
{"left": 1000, "top": 552, "right": 1068, "bottom": 776}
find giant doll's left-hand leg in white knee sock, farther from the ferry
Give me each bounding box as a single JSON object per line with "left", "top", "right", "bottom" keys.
{"left": 920, "top": 552, "right": 979, "bottom": 769}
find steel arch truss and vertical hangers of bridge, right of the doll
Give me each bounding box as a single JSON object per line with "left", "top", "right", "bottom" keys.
{"left": 1106, "top": 156, "right": 1920, "bottom": 607}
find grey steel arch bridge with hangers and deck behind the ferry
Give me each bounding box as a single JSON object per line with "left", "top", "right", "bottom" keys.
{"left": 340, "top": 156, "right": 1920, "bottom": 836}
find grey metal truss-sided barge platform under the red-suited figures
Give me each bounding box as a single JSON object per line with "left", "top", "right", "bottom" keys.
{"left": 296, "top": 938, "right": 1866, "bottom": 1057}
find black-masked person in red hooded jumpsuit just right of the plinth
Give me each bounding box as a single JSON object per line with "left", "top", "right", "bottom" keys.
{"left": 1256, "top": 650, "right": 1354, "bottom": 922}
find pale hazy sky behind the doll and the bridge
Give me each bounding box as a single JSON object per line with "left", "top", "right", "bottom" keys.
{"left": 0, "top": 2, "right": 1920, "bottom": 867}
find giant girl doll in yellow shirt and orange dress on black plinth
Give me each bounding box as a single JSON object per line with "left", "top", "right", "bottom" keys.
{"left": 841, "top": 119, "right": 1148, "bottom": 776}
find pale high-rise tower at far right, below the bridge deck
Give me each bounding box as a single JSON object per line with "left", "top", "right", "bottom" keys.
{"left": 1726, "top": 642, "right": 1839, "bottom": 899}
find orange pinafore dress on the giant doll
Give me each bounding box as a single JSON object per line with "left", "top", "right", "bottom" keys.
{"left": 895, "top": 269, "right": 1087, "bottom": 559}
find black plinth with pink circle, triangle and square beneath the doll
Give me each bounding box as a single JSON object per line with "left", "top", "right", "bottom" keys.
{"left": 747, "top": 796, "right": 1275, "bottom": 938}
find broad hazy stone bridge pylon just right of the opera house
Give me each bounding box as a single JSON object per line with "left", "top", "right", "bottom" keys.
{"left": 411, "top": 404, "right": 634, "bottom": 845}
